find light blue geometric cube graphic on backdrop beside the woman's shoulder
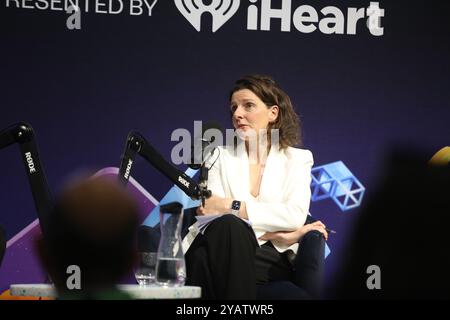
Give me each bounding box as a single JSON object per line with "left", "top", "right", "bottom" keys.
{"left": 311, "top": 161, "right": 366, "bottom": 211}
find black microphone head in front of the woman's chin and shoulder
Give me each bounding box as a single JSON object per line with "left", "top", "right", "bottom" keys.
{"left": 188, "top": 122, "right": 223, "bottom": 170}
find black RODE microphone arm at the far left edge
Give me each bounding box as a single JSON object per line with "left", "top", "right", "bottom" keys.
{"left": 0, "top": 122, "right": 54, "bottom": 236}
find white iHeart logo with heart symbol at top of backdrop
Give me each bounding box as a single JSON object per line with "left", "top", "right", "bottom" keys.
{"left": 175, "top": 0, "right": 385, "bottom": 36}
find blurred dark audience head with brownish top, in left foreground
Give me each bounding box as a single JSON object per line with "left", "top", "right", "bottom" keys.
{"left": 38, "top": 178, "right": 138, "bottom": 294}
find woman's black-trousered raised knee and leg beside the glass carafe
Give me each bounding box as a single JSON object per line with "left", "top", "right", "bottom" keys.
{"left": 185, "top": 214, "right": 258, "bottom": 300}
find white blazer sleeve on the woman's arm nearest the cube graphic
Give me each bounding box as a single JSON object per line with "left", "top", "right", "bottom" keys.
{"left": 246, "top": 150, "right": 313, "bottom": 232}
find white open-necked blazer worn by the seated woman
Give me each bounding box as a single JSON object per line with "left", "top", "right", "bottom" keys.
{"left": 183, "top": 143, "right": 313, "bottom": 253}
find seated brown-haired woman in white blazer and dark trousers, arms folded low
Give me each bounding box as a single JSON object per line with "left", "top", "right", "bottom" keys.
{"left": 186, "top": 75, "right": 328, "bottom": 299}
